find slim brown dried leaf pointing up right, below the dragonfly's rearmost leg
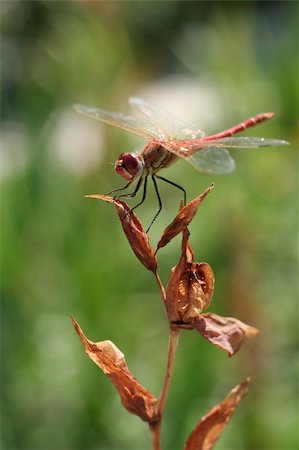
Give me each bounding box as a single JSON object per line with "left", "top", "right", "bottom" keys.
{"left": 156, "top": 183, "right": 214, "bottom": 253}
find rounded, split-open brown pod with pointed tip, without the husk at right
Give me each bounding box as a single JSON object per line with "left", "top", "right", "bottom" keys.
{"left": 166, "top": 228, "right": 214, "bottom": 326}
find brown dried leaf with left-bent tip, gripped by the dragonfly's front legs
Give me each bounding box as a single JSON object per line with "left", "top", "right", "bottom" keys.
{"left": 85, "top": 194, "right": 158, "bottom": 273}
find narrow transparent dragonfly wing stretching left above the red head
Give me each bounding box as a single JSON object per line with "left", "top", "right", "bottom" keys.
{"left": 73, "top": 105, "right": 165, "bottom": 140}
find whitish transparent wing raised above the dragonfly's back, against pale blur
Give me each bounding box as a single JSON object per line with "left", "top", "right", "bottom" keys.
{"left": 129, "top": 97, "right": 204, "bottom": 141}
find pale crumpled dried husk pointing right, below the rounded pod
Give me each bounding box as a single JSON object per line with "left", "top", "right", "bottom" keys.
{"left": 195, "top": 313, "right": 259, "bottom": 356}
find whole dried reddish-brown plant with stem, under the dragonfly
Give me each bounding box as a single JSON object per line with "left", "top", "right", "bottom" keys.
{"left": 72, "top": 185, "right": 259, "bottom": 450}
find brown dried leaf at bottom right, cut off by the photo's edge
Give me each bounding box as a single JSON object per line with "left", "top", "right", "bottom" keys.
{"left": 184, "top": 378, "right": 250, "bottom": 450}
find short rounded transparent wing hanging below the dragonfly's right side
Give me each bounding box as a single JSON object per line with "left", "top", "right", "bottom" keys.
{"left": 188, "top": 147, "right": 236, "bottom": 174}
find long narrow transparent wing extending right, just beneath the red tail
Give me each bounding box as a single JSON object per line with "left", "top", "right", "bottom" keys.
{"left": 204, "top": 137, "right": 289, "bottom": 150}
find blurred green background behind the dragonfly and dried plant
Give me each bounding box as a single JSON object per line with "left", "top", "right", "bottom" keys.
{"left": 0, "top": 1, "right": 298, "bottom": 450}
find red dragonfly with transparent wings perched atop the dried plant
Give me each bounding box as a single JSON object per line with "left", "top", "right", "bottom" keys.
{"left": 73, "top": 97, "right": 289, "bottom": 232}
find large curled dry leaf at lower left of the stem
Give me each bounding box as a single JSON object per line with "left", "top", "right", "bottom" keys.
{"left": 71, "top": 317, "right": 158, "bottom": 423}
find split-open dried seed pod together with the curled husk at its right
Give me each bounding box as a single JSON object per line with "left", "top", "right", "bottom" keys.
{"left": 165, "top": 229, "right": 259, "bottom": 356}
